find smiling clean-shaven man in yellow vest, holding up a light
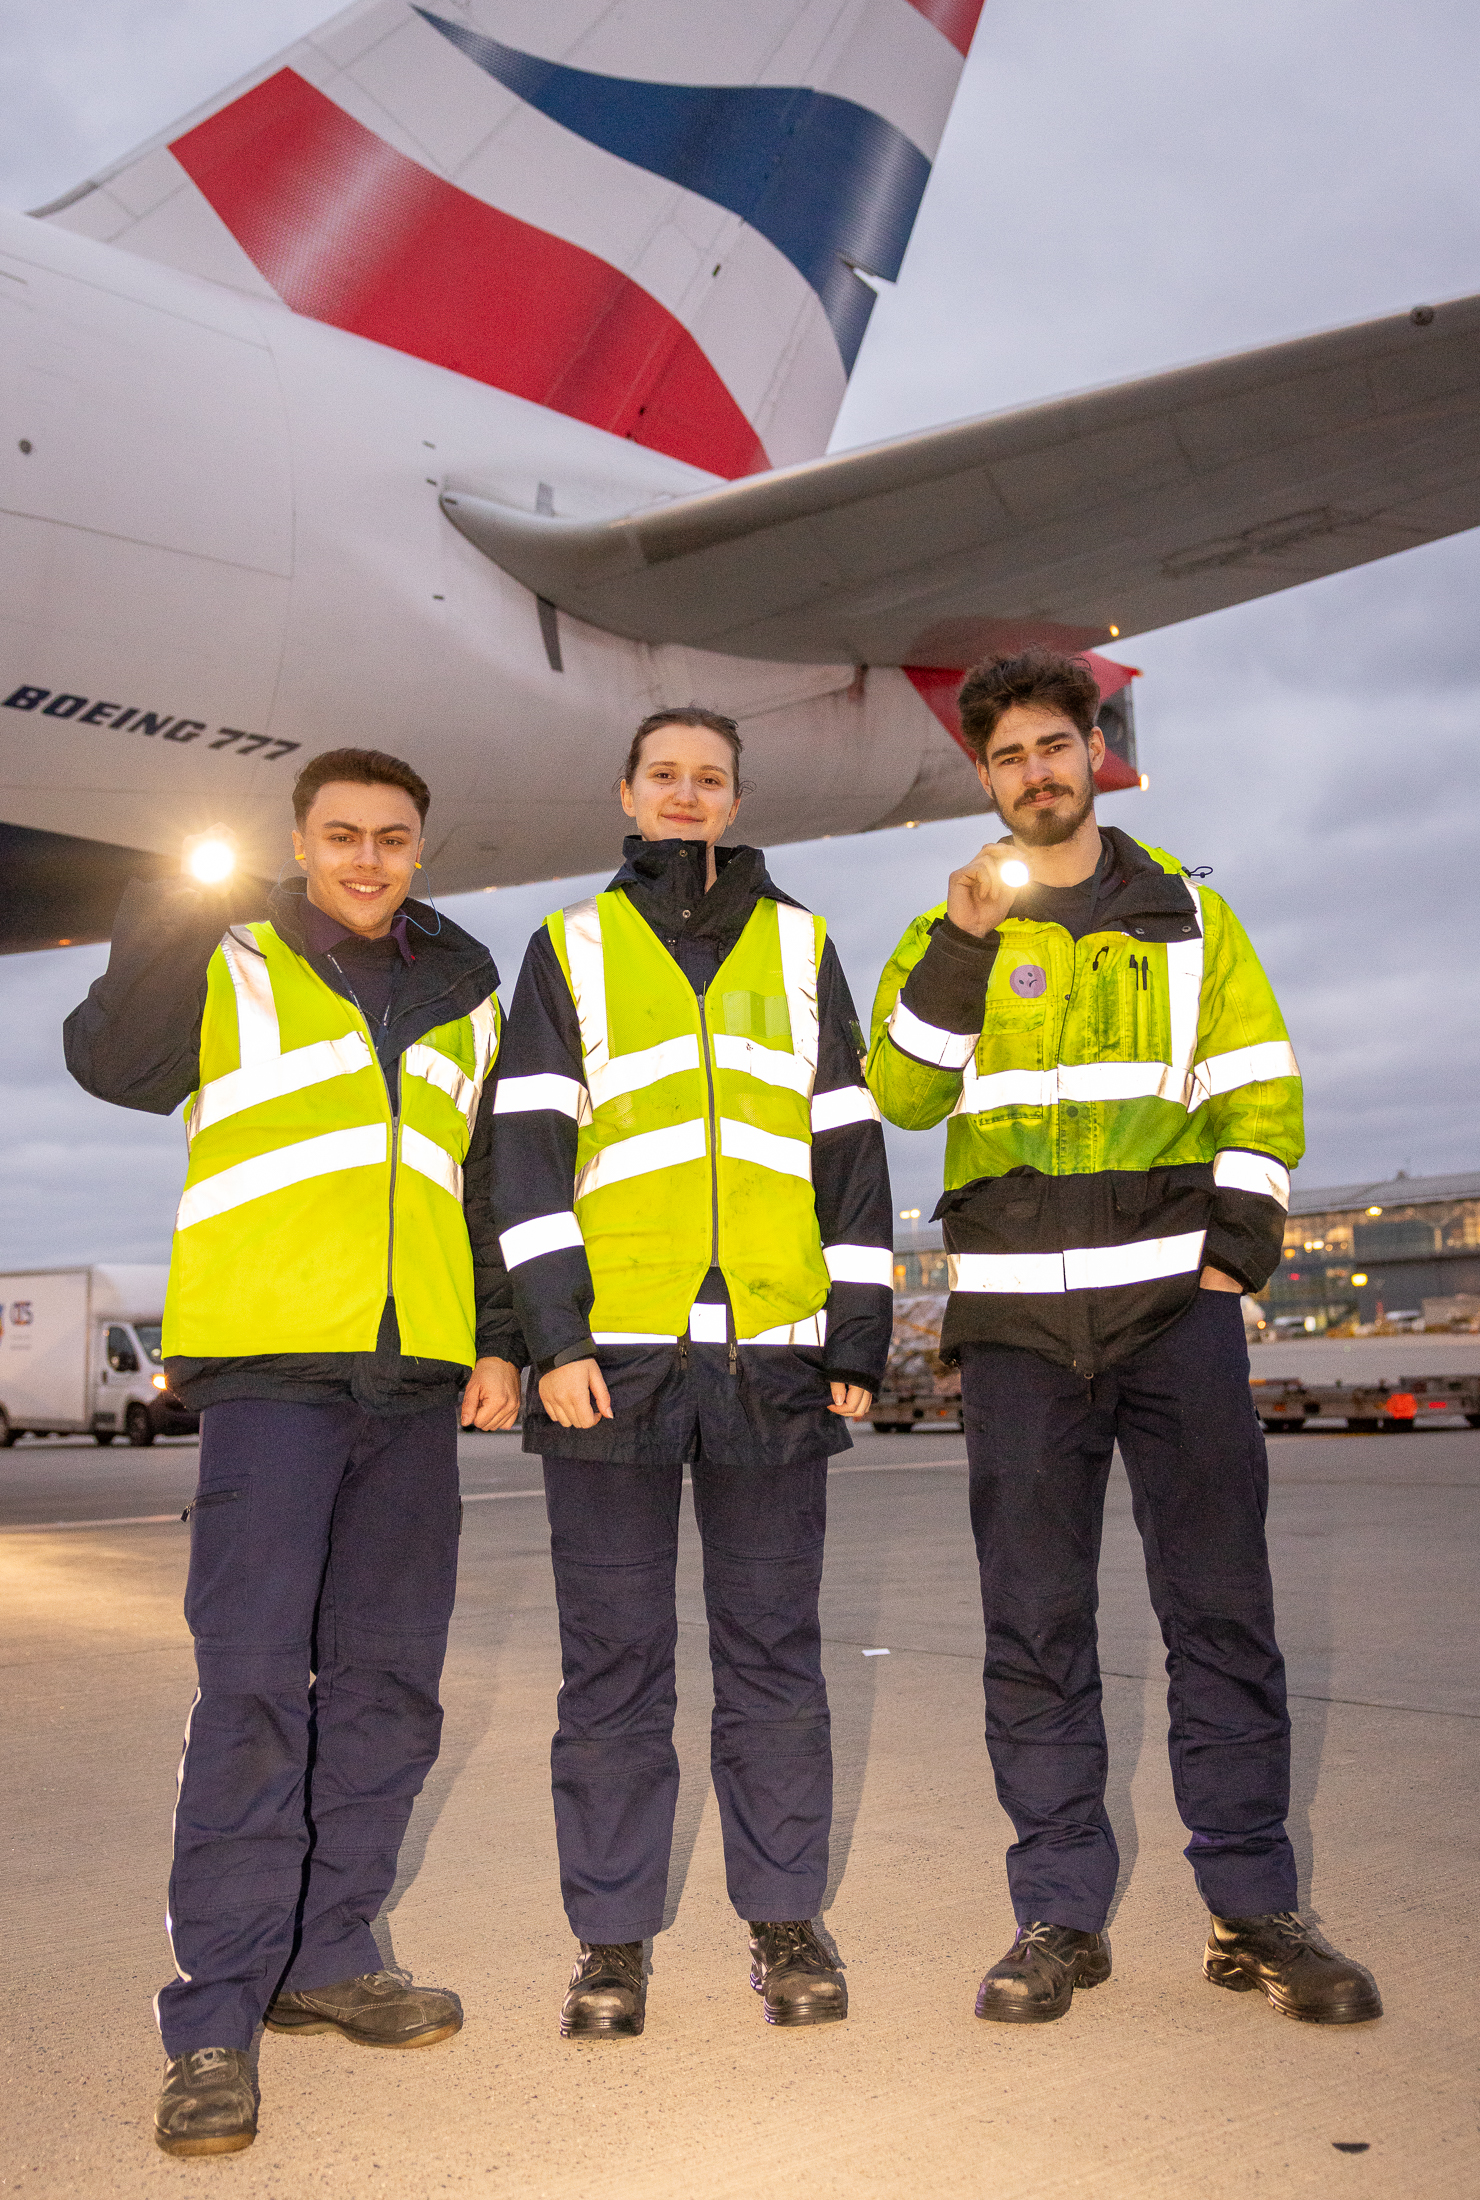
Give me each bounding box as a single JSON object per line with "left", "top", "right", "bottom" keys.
{"left": 66, "top": 748, "right": 523, "bottom": 2156}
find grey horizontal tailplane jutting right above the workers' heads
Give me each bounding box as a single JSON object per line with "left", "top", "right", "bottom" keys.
{"left": 442, "top": 297, "right": 1480, "bottom": 667}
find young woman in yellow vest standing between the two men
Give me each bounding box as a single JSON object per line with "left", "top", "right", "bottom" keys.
{"left": 495, "top": 708, "right": 893, "bottom": 2037}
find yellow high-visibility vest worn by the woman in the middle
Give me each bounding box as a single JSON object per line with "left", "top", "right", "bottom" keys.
{"left": 548, "top": 893, "right": 829, "bottom": 1344}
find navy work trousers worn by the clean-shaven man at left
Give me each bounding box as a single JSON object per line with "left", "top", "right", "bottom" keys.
{"left": 156, "top": 1399, "right": 457, "bottom": 2055}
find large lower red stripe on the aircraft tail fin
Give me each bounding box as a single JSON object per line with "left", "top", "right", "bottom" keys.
{"left": 169, "top": 68, "right": 770, "bottom": 480}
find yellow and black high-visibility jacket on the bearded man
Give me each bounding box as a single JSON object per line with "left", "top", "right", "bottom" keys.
{"left": 869, "top": 832, "right": 1304, "bottom": 1373}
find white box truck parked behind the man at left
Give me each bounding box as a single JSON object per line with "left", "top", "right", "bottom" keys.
{"left": 0, "top": 1265, "right": 200, "bottom": 1445}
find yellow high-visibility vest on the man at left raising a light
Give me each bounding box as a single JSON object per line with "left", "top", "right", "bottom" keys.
{"left": 165, "top": 924, "right": 499, "bottom": 1366}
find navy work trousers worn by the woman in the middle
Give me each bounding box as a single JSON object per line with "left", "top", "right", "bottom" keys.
{"left": 545, "top": 1459, "right": 833, "bottom": 1943}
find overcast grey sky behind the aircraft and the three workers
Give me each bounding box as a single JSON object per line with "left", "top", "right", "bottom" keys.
{"left": 0, "top": 0, "right": 1480, "bottom": 1267}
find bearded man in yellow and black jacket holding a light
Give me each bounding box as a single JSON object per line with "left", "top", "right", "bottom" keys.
{"left": 869, "top": 649, "right": 1381, "bottom": 2024}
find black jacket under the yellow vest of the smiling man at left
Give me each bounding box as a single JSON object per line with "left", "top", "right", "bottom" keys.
{"left": 64, "top": 878, "right": 526, "bottom": 1412}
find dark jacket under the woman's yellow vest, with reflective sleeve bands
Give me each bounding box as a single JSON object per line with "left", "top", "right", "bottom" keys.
{"left": 493, "top": 838, "right": 893, "bottom": 1463}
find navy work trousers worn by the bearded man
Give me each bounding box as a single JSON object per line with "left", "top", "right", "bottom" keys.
{"left": 961, "top": 1291, "right": 1295, "bottom": 1932}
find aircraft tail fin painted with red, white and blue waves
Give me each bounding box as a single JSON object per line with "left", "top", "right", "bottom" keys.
{"left": 37, "top": 0, "right": 981, "bottom": 477}
